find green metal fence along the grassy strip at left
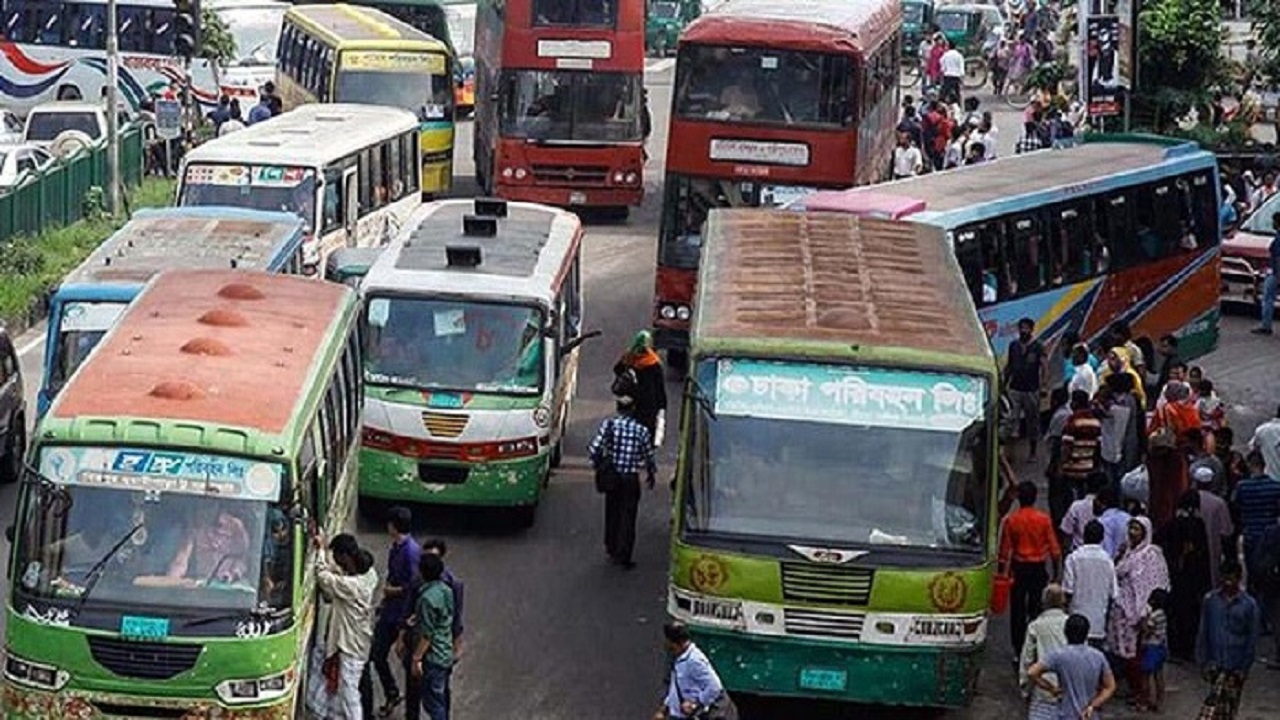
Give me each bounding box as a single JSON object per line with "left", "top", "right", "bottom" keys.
{"left": 0, "top": 128, "right": 143, "bottom": 241}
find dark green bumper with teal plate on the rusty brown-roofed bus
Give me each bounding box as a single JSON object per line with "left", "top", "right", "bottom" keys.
{"left": 689, "top": 625, "right": 982, "bottom": 707}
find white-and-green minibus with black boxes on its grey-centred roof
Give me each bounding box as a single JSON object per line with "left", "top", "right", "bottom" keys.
{"left": 350, "top": 200, "right": 588, "bottom": 525}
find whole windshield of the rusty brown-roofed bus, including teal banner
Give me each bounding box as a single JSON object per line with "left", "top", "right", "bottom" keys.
{"left": 685, "top": 360, "right": 991, "bottom": 551}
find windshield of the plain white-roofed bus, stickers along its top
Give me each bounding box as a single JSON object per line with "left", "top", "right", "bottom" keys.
{"left": 178, "top": 164, "right": 316, "bottom": 233}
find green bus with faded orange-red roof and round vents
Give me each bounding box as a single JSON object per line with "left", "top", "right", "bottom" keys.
{"left": 0, "top": 270, "right": 362, "bottom": 720}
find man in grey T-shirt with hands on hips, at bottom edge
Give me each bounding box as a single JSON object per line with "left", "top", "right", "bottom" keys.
{"left": 1027, "top": 615, "right": 1116, "bottom": 720}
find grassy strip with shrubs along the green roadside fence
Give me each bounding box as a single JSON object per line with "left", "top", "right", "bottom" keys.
{"left": 0, "top": 178, "right": 174, "bottom": 323}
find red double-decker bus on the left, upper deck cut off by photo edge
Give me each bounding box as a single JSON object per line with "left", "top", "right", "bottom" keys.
{"left": 474, "top": 0, "right": 645, "bottom": 211}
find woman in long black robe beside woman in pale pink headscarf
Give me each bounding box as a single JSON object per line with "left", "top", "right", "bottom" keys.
{"left": 1156, "top": 489, "right": 1213, "bottom": 659}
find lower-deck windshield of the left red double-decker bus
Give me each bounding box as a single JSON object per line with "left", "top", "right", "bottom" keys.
{"left": 499, "top": 70, "right": 643, "bottom": 142}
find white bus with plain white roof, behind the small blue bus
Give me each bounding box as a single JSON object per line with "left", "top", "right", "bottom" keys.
{"left": 178, "top": 104, "right": 421, "bottom": 274}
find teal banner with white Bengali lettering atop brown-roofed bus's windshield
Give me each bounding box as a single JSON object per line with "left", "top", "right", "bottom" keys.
{"left": 716, "top": 359, "right": 987, "bottom": 430}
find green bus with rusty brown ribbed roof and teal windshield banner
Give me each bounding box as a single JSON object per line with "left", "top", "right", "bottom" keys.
{"left": 668, "top": 209, "right": 997, "bottom": 707}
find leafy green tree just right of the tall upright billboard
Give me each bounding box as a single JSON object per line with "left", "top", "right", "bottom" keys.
{"left": 1138, "top": 0, "right": 1223, "bottom": 92}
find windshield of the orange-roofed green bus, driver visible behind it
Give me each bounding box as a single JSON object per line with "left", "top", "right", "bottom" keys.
{"left": 18, "top": 447, "right": 293, "bottom": 611}
